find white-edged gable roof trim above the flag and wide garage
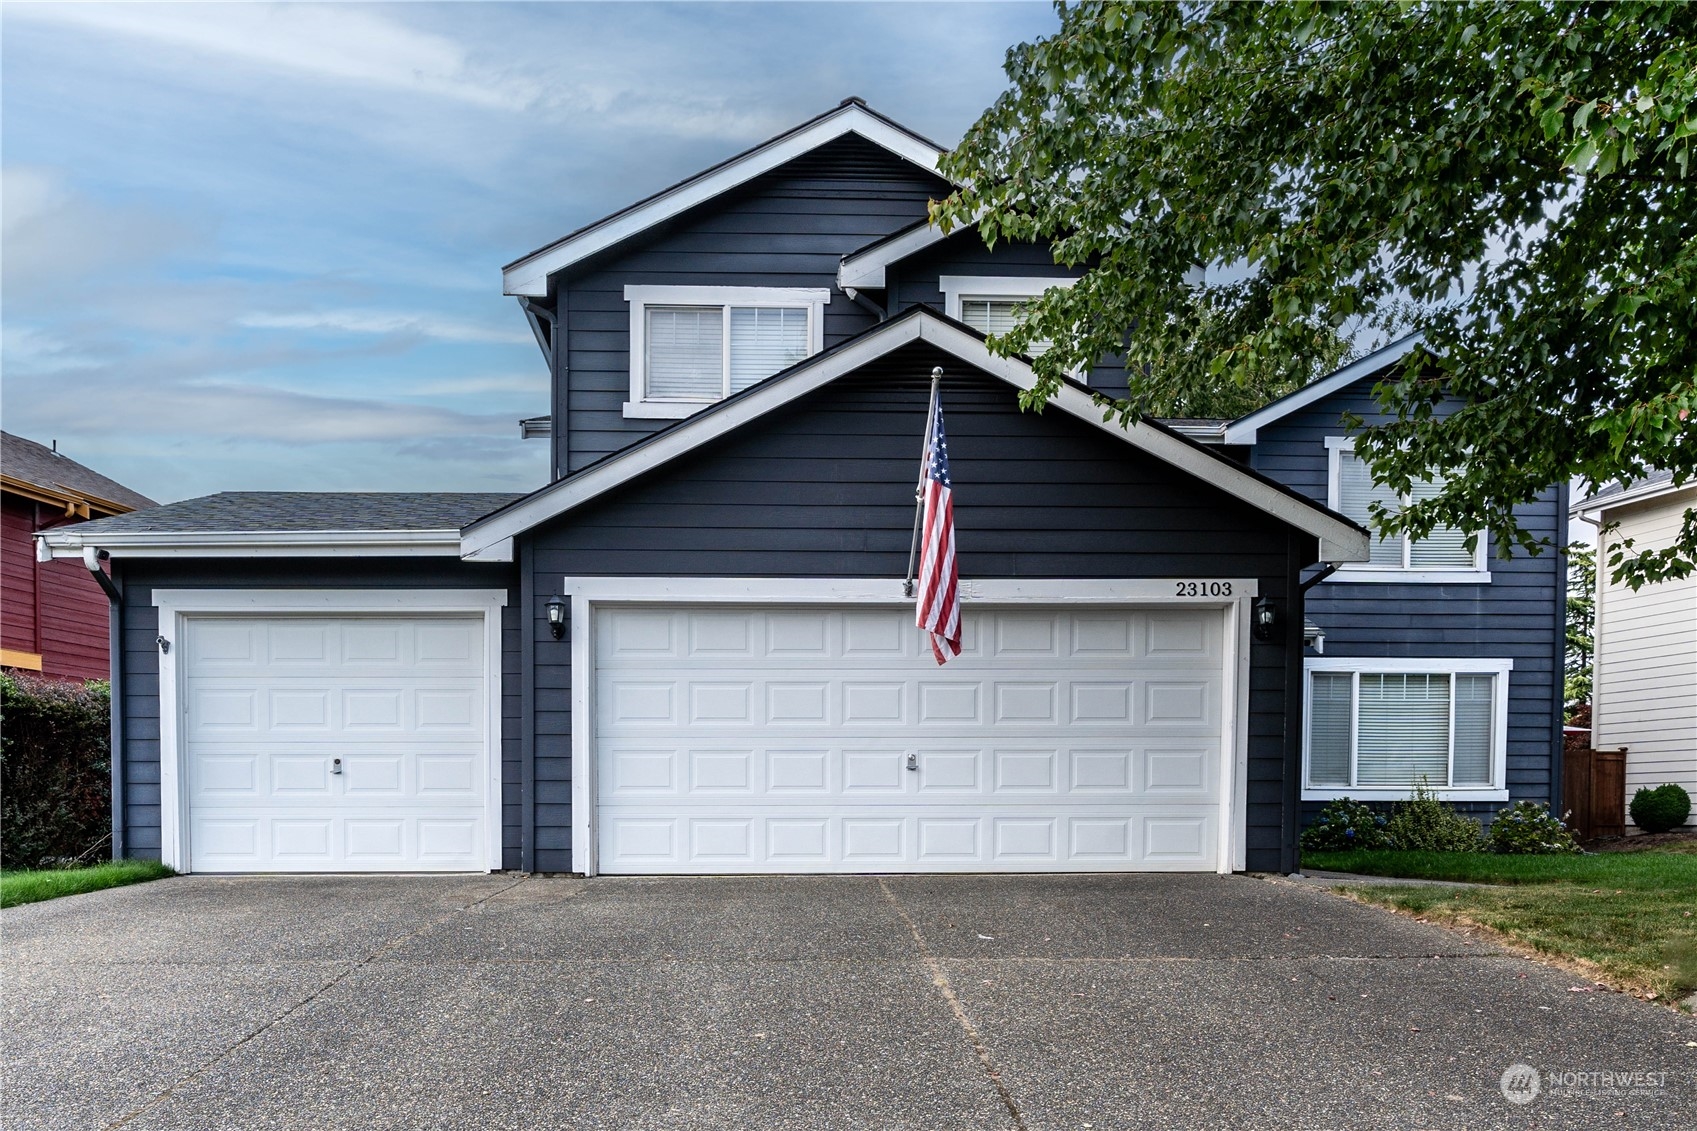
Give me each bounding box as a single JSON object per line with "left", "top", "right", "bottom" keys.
{"left": 462, "top": 306, "right": 1368, "bottom": 562}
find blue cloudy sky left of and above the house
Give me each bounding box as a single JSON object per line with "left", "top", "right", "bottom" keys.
{"left": 0, "top": 3, "right": 1056, "bottom": 501}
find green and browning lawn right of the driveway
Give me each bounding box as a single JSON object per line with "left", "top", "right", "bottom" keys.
{"left": 1302, "top": 846, "right": 1697, "bottom": 1000}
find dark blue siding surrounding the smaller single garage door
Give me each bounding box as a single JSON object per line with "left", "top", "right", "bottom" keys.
{"left": 117, "top": 557, "right": 521, "bottom": 868}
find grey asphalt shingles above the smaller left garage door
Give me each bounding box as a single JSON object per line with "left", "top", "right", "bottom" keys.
{"left": 62, "top": 491, "right": 521, "bottom": 537}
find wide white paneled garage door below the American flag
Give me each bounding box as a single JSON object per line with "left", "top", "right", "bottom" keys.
{"left": 594, "top": 606, "right": 1225, "bottom": 873}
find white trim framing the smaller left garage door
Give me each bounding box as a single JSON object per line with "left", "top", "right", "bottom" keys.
{"left": 153, "top": 589, "right": 507, "bottom": 871}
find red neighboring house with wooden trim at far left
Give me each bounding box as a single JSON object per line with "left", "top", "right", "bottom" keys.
{"left": 0, "top": 431, "right": 158, "bottom": 679}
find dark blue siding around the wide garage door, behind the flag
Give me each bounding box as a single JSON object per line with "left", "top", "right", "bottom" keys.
{"left": 526, "top": 346, "right": 1313, "bottom": 871}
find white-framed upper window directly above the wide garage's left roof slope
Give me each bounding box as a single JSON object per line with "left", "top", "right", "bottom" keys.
{"left": 624, "top": 287, "right": 830, "bottom": 418}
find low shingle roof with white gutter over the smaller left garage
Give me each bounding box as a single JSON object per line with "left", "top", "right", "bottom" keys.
{"left": 41, "top": 491, "right": 521, "bottom": 557}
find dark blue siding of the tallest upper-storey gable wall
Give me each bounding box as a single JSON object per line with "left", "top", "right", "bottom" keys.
{"left": 553, "top": 136, "right": 949, "bottom": 470}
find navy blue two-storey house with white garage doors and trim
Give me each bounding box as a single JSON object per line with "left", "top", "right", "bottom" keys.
{"left": 42, "top": 100, "right": 1565, "bottom": 875}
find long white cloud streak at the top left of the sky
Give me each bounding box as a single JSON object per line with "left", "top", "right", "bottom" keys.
{"left": 7, "top": 3, "right": 540, "bottom": 110}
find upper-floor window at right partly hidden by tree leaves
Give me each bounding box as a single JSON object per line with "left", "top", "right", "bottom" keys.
{"left": 1327, "top": 436, "right": 1490, "bottom": 581}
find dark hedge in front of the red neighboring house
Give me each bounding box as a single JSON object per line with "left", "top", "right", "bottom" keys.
{"left": 0, "top": 674, "right": 112, "bottom": 869}
